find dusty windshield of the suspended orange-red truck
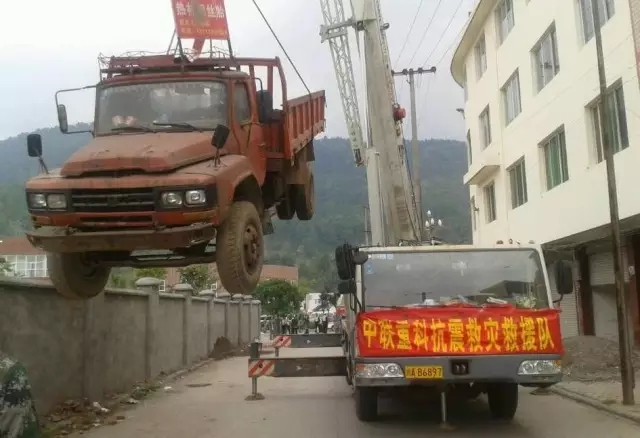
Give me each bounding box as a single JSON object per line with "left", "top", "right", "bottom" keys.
{"left": 96, "top": 81, "right": 227, "bottom": 135}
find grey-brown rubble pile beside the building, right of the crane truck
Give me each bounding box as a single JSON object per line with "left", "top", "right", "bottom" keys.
{"left": 563, "top": 336, "right": 640, "bottom": 382}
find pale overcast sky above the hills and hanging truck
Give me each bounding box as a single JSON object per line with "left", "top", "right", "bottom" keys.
{"left": 0, "top": 0, "right": 475, "bottom": 140}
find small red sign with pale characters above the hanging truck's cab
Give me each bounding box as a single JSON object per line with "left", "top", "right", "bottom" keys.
{"left": 171, "top": 0, "right": 229, "bottom": 40}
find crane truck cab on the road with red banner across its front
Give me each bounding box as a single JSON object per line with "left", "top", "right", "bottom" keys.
{"left": 336, "top": 245, "right": 573, "bottom": 421}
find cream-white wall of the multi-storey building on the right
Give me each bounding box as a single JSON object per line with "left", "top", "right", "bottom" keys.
{"left": 452, "top": 0, "right": 640, "bottom": 243}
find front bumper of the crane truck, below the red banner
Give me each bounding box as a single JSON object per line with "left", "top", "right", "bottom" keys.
{"left": 355, "top": 354, "right": 562, "bottom": 387}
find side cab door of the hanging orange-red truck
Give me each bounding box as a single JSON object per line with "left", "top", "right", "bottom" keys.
{"left": 232, "top": 82, "right": 267, "bottom": 185}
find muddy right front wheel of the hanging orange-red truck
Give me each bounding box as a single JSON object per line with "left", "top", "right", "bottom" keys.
{"left": 216, "top": 201, "right": 264, "bottom": 295}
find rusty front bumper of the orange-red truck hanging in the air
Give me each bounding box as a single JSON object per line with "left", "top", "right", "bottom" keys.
{"left": 26, "top": 223, "right": 216, "bottom": 253}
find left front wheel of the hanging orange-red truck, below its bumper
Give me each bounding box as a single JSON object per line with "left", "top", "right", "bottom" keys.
{"left": 47, "top": 252, "right": 111, "bottom": 300}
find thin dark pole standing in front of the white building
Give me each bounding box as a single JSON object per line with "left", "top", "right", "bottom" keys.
{"left": 591, "top": 0, "right": 635, "bottom": 405}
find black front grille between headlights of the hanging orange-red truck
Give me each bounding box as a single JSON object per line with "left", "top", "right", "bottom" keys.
{"left": 71, "top": 189, "right": 154, "bottom": 213}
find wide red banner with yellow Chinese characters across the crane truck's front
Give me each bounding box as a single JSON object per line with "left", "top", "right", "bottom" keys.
{"left": 356, "top": 306, "right": 564, "bottom": 357}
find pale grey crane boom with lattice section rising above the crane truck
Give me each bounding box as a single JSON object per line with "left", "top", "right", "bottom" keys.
{"left": 321, "top": 0, "right": 421, "bottom": 245}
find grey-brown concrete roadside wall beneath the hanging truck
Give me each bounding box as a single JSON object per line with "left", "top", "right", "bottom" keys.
{"left": 0, "top": 279, "right": 261, "bottom": 413}
